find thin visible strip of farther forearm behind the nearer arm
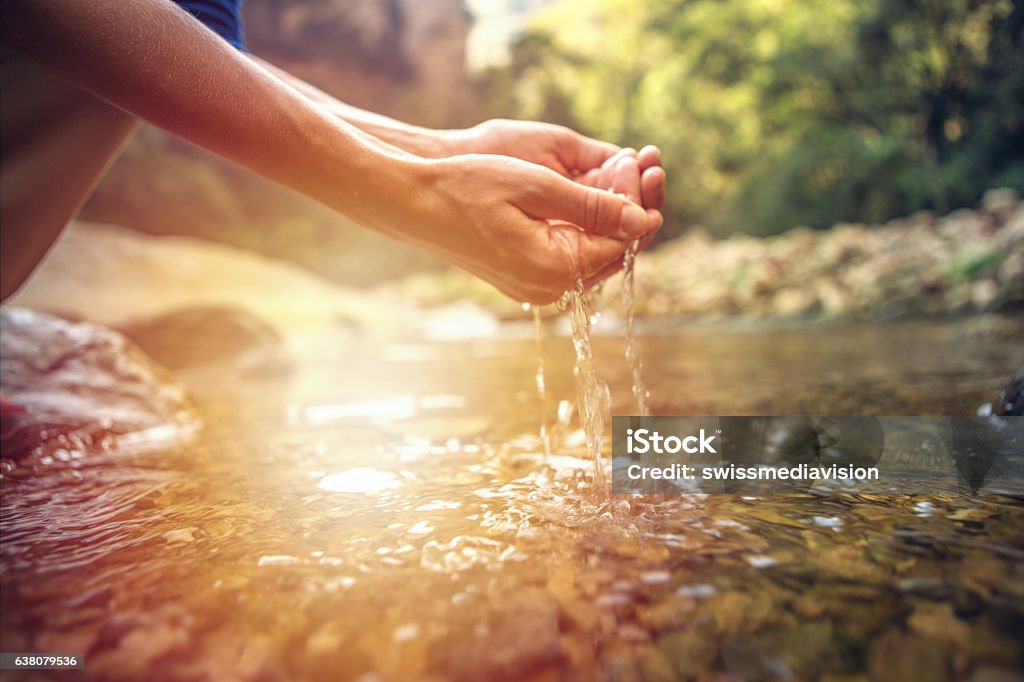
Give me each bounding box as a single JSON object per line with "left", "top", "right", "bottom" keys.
{"left": 250, "top": 55, "right": 458, "bottom": 159}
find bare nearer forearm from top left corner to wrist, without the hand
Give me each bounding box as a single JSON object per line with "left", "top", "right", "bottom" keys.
{"left": 0, "top": 0, "right": 425, "bottom": 231}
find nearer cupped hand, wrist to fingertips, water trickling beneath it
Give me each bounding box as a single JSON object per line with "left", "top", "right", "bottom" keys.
{"left": 412, "top": 155, "right": 660, "bottom": 304}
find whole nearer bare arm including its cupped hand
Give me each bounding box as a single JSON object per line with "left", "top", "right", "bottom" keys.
{"left": 0, "top": 0, "right": 660, "bottom": 303}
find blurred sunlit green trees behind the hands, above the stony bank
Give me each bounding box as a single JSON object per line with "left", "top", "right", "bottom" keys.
{"left": 487, "top": 0, "right": 1024, "bottom": 235}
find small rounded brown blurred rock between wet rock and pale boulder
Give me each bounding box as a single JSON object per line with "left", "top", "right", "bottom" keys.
{"left": 120, "top": 305, "right": 292, "bottom": 376}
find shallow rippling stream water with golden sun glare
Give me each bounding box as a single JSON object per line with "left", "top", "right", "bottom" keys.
{"left": 0, "top": 325, "right": 1024, "bottom": 682}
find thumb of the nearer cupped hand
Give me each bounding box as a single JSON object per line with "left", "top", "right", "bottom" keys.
{"left": 520, "top": 173, "right": 653, "bottom": 240}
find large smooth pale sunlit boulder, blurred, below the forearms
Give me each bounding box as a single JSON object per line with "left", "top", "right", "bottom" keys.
{"left": 6, "top": 222, "right": 420, "bottom": 346}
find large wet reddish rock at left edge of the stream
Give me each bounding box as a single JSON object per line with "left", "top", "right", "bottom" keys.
{"left": 0, "top": 307, "right": 200, "bottom": 459}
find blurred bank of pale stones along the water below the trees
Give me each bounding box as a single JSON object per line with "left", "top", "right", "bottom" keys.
{"left": 384, "top": 189, "right": 1024, "bottom": 322}
